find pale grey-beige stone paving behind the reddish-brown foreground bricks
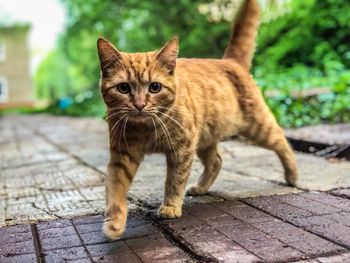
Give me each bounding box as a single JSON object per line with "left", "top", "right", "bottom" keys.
{"left": 0, "top": 115, "right": 350, "bottom": 225}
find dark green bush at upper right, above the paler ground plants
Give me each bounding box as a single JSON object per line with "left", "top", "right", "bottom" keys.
{"left": 255, "top": 0, "right": 350, "bottom": 73}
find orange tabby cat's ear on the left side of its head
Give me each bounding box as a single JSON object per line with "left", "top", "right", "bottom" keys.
{"left": 97, "top": 37, "right": 123, "bottom": 72}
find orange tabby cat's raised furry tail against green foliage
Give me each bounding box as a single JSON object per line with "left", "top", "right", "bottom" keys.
{"left": 223, "top": 0, "right": 260, "bottom": 70}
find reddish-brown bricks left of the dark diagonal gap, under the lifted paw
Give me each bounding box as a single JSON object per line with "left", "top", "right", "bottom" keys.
{"left": 0, "top": 213, "right": 192, "bottom": 262}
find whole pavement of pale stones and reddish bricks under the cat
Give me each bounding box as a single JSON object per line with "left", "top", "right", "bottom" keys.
{"left": 0, "top": 115, "right": 350, "bottom": 262}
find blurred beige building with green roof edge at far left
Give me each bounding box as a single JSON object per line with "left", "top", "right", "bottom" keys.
{"left": 0, "top": 25, "right": 34, "bottom": 109}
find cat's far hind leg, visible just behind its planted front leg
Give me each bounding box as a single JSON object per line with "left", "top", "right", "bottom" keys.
{"left": 187, "top": 144, "right": 222, "bottom": 195}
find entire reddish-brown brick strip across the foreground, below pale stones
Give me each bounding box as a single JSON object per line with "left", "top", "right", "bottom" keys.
{"left": 0, "top": 192, "right": 350, "bottom": 262}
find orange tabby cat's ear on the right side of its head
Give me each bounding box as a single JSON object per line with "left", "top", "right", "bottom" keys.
{"left": 156, "top": 37, "right": 179, "bottom": 75}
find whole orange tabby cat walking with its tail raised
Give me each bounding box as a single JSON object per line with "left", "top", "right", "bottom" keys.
{"left": 98, "top": 0, "right": 298, "bottom": 239}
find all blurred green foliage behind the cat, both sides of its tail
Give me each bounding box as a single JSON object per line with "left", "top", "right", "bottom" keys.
{"left": 36, "top": 0, "right": 350, "bottom": 127}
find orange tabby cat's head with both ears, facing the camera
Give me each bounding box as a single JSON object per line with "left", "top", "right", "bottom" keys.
{"left": 97, "top": 37, "right": 179, "bottom": 122}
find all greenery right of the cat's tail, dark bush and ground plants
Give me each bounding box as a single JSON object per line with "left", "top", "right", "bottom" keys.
{"left": 254, "top": 0, "right": 350, "bottom": 127}
